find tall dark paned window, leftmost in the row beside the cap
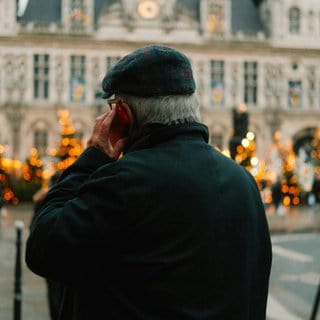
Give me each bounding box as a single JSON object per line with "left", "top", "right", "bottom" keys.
{"left": 33, "top": 54, "right": 49, "bottom": 99}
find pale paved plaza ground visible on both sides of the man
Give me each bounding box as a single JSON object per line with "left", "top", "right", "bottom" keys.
{"left": 0, "top": 204, "right": 320, "bottom": 320}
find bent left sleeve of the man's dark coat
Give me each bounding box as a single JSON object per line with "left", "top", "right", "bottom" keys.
{"left": 25, "top": 148, "right": 125, "bottom": 285}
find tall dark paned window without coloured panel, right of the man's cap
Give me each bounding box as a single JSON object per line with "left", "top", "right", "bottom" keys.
{"left": 244, "top": 62, "right": 258, "bottom": 104}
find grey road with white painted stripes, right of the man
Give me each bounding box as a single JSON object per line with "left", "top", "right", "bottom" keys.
{"left": 267, "top": 232, "right": 320, "bottom": 320}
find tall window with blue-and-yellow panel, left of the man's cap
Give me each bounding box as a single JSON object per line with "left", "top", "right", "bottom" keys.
{"left": 70, "top": 56, "right": 86, "bottom": 102}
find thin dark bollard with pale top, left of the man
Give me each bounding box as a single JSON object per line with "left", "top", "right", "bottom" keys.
{"left": 13, "top": 220, "right": 24, "bottom": 320}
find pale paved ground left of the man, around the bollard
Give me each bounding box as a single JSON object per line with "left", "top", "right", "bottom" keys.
{"left": 0, "top": 205, "right": 49, "bottom": 320}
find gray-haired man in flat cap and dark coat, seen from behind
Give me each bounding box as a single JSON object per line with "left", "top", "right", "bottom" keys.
{"left": 26, "top": 45, "right": 271, "bottom": 320}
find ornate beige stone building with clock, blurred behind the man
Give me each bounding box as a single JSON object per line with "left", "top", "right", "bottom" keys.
{"left": 0, "top": 0, "right": 320, "bottom": 172}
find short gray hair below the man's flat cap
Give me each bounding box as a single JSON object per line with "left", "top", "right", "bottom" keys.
{"left": 117, "top": 94, "right": 201, "bottom": 128}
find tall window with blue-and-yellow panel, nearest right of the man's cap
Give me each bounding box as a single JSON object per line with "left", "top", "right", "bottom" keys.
{"left": 211, "top": 60, "right": 225, "bottom": 106}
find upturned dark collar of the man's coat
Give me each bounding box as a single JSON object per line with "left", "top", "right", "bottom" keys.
{"left": 127, "top": 122, "right": 209, "bottom": 152}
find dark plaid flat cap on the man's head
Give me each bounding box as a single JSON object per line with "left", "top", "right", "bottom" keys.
{"left": 102, "top": 45, "right": 195, "bottom": 98}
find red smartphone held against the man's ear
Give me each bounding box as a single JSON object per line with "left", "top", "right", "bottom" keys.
{"left": 109, "top": 100, "right": 130, "bottom": 145}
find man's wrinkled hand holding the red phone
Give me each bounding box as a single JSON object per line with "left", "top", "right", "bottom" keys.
{"left": 88, "top": 109, "right": 126, "bottom": 160}
